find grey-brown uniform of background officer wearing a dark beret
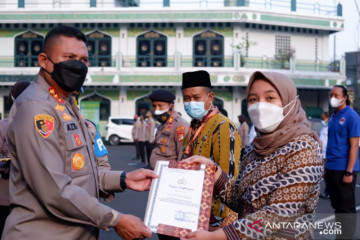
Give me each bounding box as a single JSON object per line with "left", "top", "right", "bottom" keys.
{"left": 150, "top": 111, "right": 189, "bottom": 169}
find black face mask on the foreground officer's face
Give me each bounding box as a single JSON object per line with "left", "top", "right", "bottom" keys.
{"left": 44, "top": 57, "right": 88, "bottom": 92}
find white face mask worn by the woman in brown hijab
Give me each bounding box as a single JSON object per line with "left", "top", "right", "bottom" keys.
{"left": 248, "top": 96, "right": 299, "bottom": 133}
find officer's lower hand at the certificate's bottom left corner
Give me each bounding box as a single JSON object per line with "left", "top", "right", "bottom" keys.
{"left": 114, "top": 214, "right": 151, "bottom": 240}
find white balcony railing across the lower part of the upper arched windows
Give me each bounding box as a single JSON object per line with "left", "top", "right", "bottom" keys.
{"left": 0, "top": 54, "right": 341, "bottom": 72}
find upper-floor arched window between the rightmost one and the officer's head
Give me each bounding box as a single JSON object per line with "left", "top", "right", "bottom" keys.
{"left": 136, "top": 31, "right": 167, "bottom": 67}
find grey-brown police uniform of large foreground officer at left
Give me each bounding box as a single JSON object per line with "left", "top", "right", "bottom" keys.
{"left": 2, "top": 75, "right": 121, "bottom": 240}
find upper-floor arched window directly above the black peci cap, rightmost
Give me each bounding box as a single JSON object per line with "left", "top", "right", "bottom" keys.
{"left": 193, "top": 30, "right": 224, "bottom": 67}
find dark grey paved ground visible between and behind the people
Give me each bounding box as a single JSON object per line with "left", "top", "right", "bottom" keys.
{"left": 100, "top": 144, "right": 360, "bottom": 240}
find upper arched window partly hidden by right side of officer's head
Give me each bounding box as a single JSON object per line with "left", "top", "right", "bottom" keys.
{"left": 86, "top": 31, "right": 111, "bottom": 67}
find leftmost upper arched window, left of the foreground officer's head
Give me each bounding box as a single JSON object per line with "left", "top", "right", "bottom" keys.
{"left": 14, "top": 31, "right": 44, "bottom": 67}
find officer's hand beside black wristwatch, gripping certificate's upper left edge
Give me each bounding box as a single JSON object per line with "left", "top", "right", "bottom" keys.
{"left": 125, "top": 169, "right": 159, "bottom": 191}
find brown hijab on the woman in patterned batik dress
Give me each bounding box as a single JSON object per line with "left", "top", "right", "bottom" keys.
{"left": 246, "top": 71, "right": 320, "bottom": 157}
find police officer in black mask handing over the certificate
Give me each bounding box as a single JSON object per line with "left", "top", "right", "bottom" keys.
{"left": 2, "top": 25, "right": 156, "bottom": 240}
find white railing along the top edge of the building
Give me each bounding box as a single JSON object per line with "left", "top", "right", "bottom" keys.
{"left": 0, "top": 0, "right": 339, "bottom": 16}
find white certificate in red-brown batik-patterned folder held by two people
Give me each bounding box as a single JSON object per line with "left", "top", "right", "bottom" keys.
{"left": 144, "top": 161, "right": 215, "bottom": 237}
